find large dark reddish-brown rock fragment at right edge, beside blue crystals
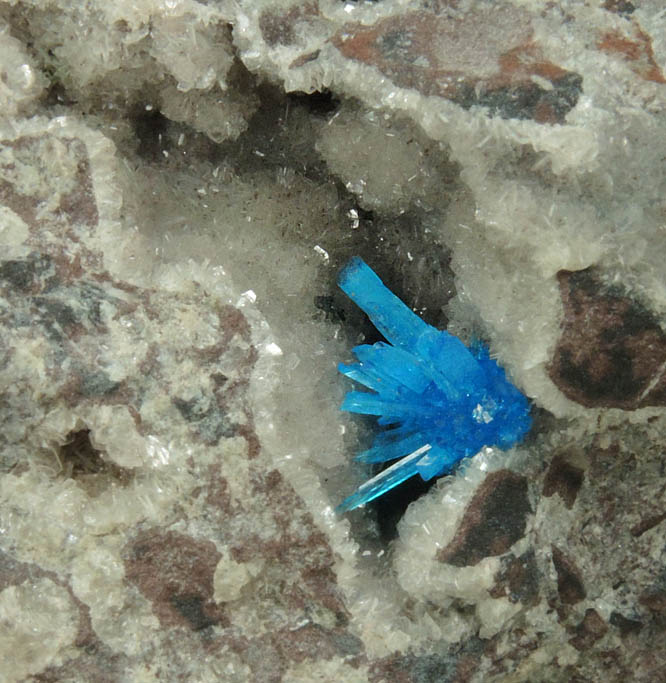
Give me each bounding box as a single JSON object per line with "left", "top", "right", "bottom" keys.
{"left": 548, "top": 269, "right": 666, "bottom": 410}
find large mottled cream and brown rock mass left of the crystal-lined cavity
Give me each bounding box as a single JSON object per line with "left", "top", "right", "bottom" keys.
{"left": 0, "top": 119, "right": 363, "bottom": 680}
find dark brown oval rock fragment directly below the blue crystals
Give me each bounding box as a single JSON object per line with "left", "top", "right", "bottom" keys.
{"left": 437, "top": 470, "right": 532, "bottom": 567}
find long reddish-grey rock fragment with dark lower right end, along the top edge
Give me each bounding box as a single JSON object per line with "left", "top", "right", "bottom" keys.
{"left": 332, "top": 7, "right": 582, "bottom": 123}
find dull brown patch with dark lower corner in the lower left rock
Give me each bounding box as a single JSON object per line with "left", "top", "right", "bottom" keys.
{"left": 124, "top": 529, "right": 228, "bottom": 631}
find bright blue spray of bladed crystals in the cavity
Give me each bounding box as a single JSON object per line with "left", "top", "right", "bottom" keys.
{"left": 338, "top": 257, "right": 531, "bottom": 512}
